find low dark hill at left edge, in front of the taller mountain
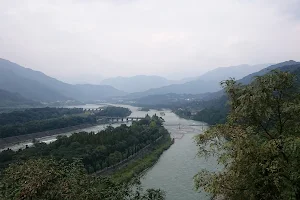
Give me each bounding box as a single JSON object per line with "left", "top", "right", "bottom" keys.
{"left": 0, "top": 89, "right": 40, "bottom": 108}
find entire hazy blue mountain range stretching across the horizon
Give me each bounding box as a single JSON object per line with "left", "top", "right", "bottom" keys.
{"left": 0, "top": 56, "right": 296, "bottom": 105}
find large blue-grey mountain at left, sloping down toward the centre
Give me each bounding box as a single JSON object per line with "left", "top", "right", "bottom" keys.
{"left": 0, "top": 59, "right": 126, "bottom": 102}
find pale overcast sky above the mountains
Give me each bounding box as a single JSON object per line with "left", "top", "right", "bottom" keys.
{"left": 0, "top": 0, "right": 300, "bottom": 82}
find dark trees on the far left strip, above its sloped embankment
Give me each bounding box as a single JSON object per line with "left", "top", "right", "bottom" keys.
{"left": 0, "top": 107, "right": 131, "bottom": 138}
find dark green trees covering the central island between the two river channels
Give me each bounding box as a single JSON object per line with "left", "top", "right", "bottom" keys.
{"left": 0, "top": 116, "right": 169, "bottom": 173}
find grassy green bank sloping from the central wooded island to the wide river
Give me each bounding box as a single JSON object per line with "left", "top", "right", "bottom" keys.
{"left": 111, "top": 135, "right": 174, "bottom": 183}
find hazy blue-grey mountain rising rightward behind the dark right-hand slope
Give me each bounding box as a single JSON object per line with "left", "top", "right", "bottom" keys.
{"left": 128, "top": 64, "right": 268, "bottom": 98}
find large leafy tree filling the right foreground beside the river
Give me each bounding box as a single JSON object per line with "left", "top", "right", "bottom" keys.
{"left": 195, "top": 71, "right": 300, "bottom": 200}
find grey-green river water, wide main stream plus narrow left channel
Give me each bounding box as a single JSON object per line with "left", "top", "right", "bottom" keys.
{"left": 2, "top": 104, "right": 218, "bottom": 200}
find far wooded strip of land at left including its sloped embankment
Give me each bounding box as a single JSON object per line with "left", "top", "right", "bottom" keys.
{"left": 0, "top": 106, "right": 131, "bottom": 149}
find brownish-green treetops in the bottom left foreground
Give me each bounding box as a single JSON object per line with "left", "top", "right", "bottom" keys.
{"left": 0, "top": 159, "right": 165, "bottom": 200}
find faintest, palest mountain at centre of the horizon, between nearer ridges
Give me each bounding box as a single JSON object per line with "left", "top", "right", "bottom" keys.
{"left": 101, "top": 75, "right": 173, "bottom": 93}
